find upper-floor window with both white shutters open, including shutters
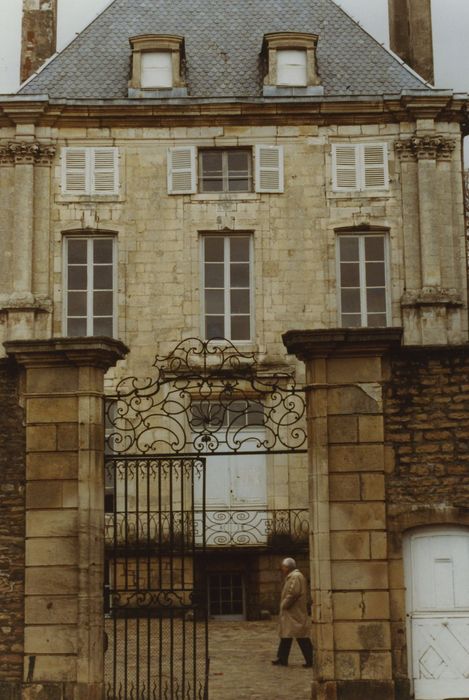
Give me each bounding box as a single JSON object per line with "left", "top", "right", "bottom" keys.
{"left": 168, "top": 144, "right": 284, "bottom": 194}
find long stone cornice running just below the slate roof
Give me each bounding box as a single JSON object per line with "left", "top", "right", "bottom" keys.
{"left": 0, "top": 91, "right": 467, "bottom": 128}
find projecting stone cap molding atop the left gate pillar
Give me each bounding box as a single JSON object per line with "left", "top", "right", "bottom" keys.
{"left": 4, "top": 336, "right": 129, "bottom": 370}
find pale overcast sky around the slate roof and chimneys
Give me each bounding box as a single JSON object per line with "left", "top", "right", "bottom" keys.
{"left": 0, "top": 0, "right": 469, "bottom": 93}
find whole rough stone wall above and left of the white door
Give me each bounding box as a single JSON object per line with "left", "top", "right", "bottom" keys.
{"left": 384, "top": 346, "right": 469, "bottom": 678}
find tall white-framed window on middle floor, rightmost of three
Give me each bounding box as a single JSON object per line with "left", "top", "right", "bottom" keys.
{"left": 337, "top": 232, "right": 390, "bottom": 327}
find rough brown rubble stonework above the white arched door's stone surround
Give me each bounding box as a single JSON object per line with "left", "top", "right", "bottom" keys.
{"left": 385, "top": 346, "right": 469, "bottom": 507}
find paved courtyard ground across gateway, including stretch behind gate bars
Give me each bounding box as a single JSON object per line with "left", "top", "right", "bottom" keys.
{"left": 105, "top": 619, "right": 312, "bottom": 700}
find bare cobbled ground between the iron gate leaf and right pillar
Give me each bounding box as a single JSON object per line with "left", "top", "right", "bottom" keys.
{"left": 209, "top": 621, "right": 312, "bottom": 700}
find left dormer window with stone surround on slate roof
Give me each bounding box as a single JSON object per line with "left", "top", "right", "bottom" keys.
{"left": 129, "top": 34, "right": 185, "bottom": 97}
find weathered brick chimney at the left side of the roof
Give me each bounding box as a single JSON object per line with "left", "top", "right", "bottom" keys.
{"left": 20, "top": 0, "right": 57, "bottom": 82}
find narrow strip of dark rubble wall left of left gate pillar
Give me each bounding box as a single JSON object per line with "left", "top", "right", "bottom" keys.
{"left": 0, "top": 360, "right": 25, "bottom": 684}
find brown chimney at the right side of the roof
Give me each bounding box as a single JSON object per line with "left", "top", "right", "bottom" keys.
{"left": 388, "top": 0, "right": 434, "bottom": 83}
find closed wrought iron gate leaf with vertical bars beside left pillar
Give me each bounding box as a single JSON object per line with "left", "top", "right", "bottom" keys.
{"left": 105, "top": 455, "right": 208, "bottom": 700}
